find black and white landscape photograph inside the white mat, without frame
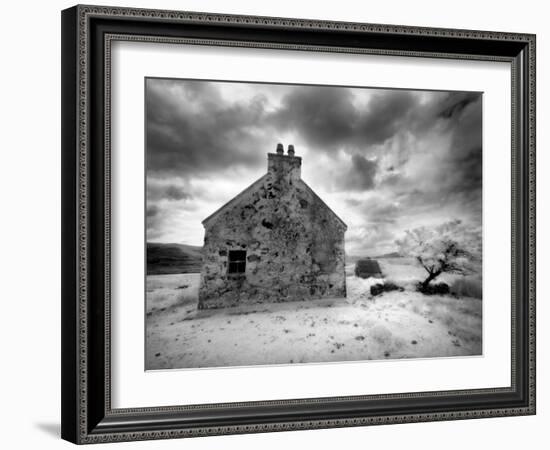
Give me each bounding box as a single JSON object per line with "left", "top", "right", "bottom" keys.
{"left": 145, "top": 78, "right": 483, "bottom": 370}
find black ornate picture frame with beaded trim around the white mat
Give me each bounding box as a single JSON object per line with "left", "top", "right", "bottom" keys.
{"left": 62, "top": 5, "right": 535, "bottom": 444}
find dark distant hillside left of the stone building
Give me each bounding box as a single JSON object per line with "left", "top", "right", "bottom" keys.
{"left": 147, "top": 242, "right": 202, "bottom": 275}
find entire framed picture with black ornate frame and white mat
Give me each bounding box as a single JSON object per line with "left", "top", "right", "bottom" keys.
{"left": 62, "top": 6, "right": 535, "bottom": 444}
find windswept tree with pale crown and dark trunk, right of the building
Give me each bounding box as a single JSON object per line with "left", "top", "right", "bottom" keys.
{"left": 396, "top": 220, "right": 481, "bottom": 291}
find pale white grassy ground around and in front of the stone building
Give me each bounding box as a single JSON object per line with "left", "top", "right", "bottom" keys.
{"left": 146, "top": 258, "right": 482, "bottom": 369}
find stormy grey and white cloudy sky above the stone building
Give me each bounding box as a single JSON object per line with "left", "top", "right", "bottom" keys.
{"left": 145, "top": 79, "right": 482, "bottom": 256}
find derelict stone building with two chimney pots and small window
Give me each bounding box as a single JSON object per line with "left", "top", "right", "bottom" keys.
{"left": 199, "top": 144, "right": 347, "bottom": 309}
